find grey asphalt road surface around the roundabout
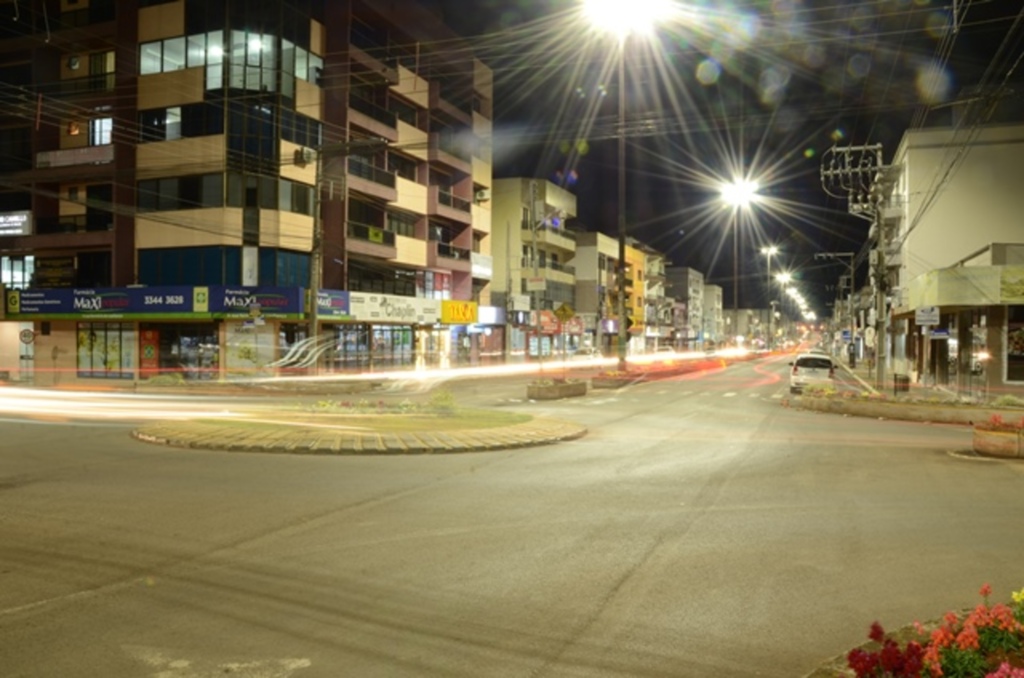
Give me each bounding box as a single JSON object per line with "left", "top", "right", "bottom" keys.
{"left": 0, "top": 359, "right": 1024, "bottom": 678}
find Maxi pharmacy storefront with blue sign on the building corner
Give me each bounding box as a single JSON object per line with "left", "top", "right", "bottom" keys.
{"left": 4, "top": 286, "right": 304, "bottom": 385}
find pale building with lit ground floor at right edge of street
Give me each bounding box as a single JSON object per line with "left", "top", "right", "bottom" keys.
{"left": 888, "top": 123, "right": 1024, "bottom": 396}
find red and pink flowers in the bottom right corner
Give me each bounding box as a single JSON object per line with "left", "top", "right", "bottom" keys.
{"left": 811, "top": 584, "right": 1024, "bottom": 678}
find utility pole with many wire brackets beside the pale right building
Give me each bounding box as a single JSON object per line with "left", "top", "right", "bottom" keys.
{"left": 821, "top": 143, "right": 890, "bottom": 390}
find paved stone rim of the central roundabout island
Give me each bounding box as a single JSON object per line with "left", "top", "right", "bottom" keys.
{"left": 132, "top": 417, "right": 587, "bottom": 455}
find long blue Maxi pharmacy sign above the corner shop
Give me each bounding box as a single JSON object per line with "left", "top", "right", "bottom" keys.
{"left": 4, "top": 286, "right": 303, "bottom": 320}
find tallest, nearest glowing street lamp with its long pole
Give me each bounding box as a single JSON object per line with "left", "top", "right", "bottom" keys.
{"left": 583, "top": 0, "right": 672, "bottom": 371}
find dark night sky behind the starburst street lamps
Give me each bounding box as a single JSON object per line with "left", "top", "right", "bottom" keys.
{"left": 426, "top": 0, "right": 1024, "bottom": 316}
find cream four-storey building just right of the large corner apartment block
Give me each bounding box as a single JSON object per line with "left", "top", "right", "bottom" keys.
{"left": 492, "top": 178, "right": 582, "bottom": 355}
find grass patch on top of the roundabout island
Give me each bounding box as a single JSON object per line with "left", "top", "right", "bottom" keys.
{"left": 199, "top": 410, "right": 532, "bottom": 433}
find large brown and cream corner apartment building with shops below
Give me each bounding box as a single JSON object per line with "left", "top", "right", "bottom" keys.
{"left": 0, "top": 0, "right": 495, "bottom": 383}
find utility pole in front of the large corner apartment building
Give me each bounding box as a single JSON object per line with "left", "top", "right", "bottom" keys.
{"left": 303, "top": 139, "right": 387, "bottom": 374}
